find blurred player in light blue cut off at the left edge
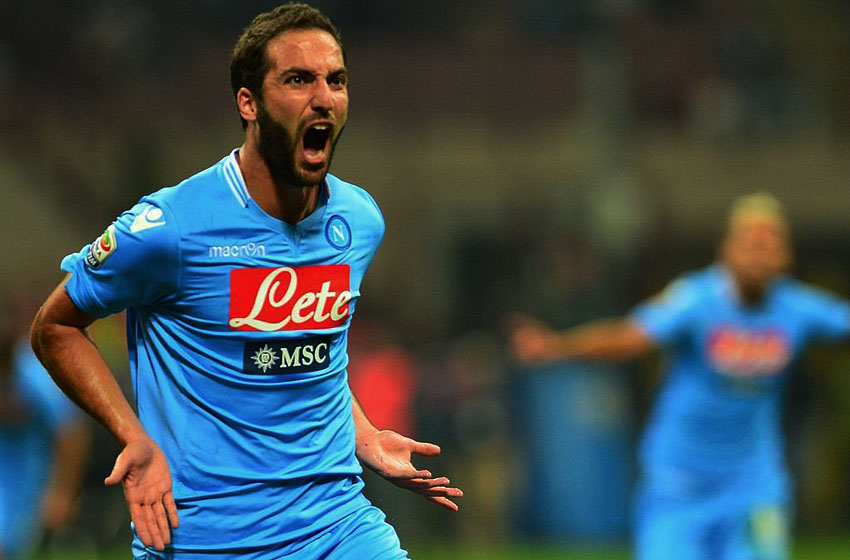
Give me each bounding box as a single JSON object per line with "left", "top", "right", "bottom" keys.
{"left": 0, "top": 322, "right": 89, "bottom": 560}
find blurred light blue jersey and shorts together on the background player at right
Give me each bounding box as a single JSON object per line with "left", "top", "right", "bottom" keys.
{"left": 632, "top": 265, "right": 850, "bottom": 559}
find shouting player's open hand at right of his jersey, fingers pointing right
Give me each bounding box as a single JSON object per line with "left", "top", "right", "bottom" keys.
{"left": 357, "top": 430, "right": 463, "bottom": 511}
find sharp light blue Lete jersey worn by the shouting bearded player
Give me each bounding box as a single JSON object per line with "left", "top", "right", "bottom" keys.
{"left": 62, "top": 151, "right": 384, "bottom": 557}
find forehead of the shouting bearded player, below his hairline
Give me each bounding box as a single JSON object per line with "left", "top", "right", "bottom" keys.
{"left": 266, "top": 29, "right": 345, "bottom": 72}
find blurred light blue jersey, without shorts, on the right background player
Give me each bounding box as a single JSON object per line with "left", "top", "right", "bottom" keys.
{"left": 632, "top": 265, "right": 850, "bottom": 482}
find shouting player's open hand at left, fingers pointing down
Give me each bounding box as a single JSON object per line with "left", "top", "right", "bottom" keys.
{"left": 104, "top": 438, "right": 179, "bottom": 550}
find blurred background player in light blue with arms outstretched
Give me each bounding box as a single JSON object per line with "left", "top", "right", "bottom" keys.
{"left": 511, "top": 193, "right": 850, "bottom": 560}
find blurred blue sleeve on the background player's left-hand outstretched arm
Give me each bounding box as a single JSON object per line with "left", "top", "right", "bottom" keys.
{"left": 630, "top": 278, "right": 699, "bottom": 344}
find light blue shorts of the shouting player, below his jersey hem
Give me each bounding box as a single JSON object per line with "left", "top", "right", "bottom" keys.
{"left": 133, "top": 505, "right": 408, "bottom": 560}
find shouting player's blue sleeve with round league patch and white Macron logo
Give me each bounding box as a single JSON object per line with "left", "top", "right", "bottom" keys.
{"left": 61, "top": 199, "right": 179, "bottom": 318}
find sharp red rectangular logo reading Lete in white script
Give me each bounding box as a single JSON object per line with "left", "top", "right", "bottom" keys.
{"left": 228, "top": 264, "right": 352, "bottom": 332}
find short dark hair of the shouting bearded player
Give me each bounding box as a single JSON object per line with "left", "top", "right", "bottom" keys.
{"left": 230, "top": 3, "right": 345, "bottom": 128}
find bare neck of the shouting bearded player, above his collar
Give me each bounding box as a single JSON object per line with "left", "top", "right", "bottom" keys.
{"left": 237, "top": 142, "right": 321, "bottom": 224}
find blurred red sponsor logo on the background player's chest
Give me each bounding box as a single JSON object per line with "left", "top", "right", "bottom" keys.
{"left": 708, "top": 325, "right": 791, "bottom": 378}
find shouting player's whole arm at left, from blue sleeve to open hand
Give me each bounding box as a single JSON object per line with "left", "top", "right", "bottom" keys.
{"left": 31, "top": 197, "right": 180, "bottom": 549}
